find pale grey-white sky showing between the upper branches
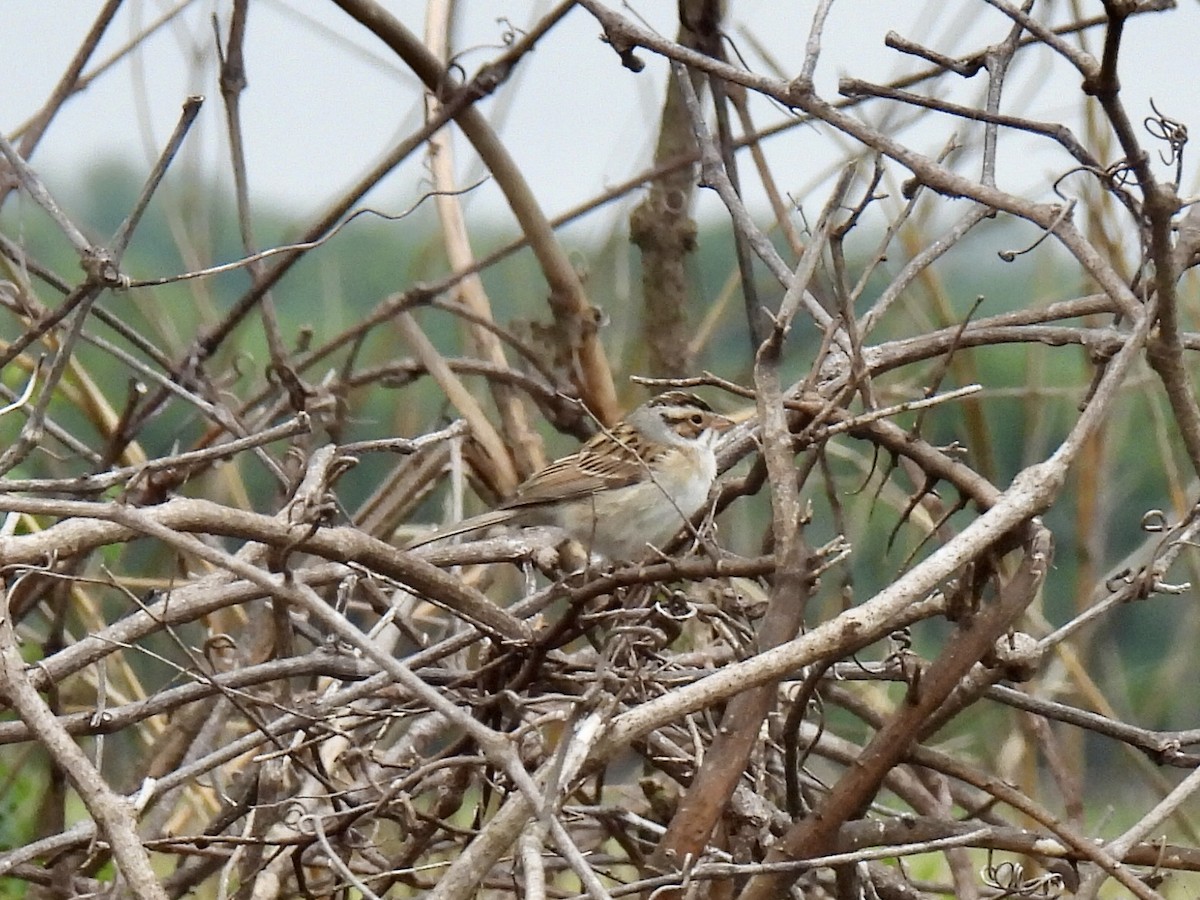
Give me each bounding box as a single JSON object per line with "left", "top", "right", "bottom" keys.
{"left": 0, "top": 0, "right": 1200, "bottom": 244}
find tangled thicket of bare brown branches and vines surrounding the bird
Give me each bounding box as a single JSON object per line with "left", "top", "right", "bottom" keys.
{"left": 0, "top": 0, "right": 1200, "bottom": 900}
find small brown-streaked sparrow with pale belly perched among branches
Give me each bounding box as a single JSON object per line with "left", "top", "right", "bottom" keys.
{"left": 406, "top": 390, "right": 734, "bottom": 562}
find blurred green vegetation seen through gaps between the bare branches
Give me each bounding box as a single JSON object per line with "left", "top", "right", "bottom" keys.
{"left": 0, "top": 164, "right": 1200, "bottom": 895}
